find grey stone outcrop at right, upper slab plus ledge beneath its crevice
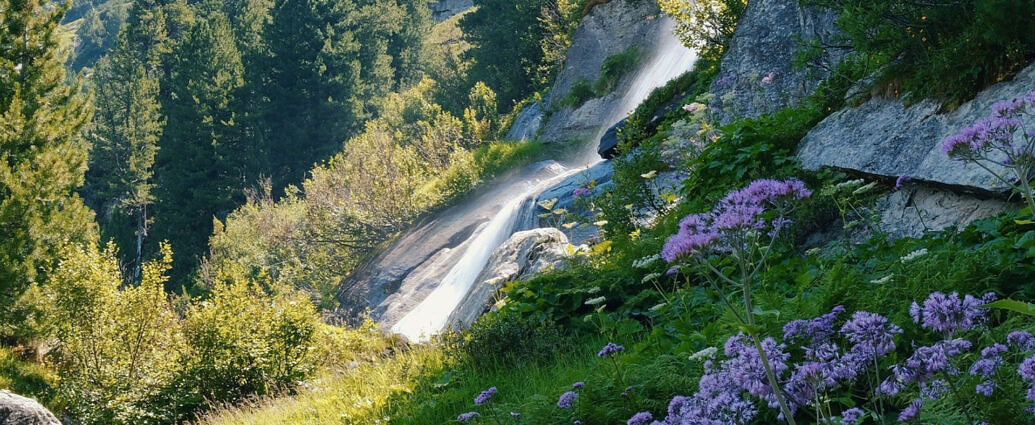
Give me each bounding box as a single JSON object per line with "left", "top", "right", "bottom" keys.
{"left": 798, "top": 65, "right": 1035, "bottom": 237}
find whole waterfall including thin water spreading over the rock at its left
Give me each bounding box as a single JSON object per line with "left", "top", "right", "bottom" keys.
{"left": 354, "top": 19, "right": 697, "bottom": 340}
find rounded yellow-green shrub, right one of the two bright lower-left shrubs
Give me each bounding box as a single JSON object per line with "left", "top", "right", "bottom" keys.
{"left": 178, "top": 266, "right": 320, "bottom": 406}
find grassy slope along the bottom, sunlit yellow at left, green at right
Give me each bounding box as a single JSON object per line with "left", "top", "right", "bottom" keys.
{"left": 197, "top": 336, "right": 697, "bottom": 425}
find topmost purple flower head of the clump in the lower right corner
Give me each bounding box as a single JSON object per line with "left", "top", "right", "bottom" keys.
{"left": 910, "top": 293, "right": 996, "bottom": 338}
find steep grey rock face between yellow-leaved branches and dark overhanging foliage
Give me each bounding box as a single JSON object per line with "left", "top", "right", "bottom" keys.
{"left": 709, "top": 0, "right": 841, "bottom": 124}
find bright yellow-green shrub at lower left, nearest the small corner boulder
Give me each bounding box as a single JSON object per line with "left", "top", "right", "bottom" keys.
{"left": 30, "top": 244, "right": 187, "bottom": 424}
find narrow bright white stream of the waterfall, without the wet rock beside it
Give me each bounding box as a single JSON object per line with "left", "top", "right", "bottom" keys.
{"left": 391, "top": 19, "right": 697, "bottom": 341}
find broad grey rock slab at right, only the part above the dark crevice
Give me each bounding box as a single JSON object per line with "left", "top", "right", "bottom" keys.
{"left": 798, "top": 65, "right": 1035, "bottom": 193}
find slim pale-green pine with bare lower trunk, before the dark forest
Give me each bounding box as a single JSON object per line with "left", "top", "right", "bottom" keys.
{"left": 87, "top": 33, "right": 165, "bottom": 278}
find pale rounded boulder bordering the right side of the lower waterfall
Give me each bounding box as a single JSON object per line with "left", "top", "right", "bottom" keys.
{"left": 448, "top": 227, "right": 568, "bottom": 329}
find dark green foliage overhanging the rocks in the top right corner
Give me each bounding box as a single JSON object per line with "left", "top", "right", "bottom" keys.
{"left": 802, "top": 0, "right": 1035, "bottom": 104}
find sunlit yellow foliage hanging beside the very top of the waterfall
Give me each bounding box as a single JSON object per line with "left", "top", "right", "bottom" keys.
{"left": 658, "top": 0, "right": 747, "bottom": 55}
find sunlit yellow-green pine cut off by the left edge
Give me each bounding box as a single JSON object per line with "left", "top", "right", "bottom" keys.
{"left": 0, "top": 0, "right": 96, "bottom": 322}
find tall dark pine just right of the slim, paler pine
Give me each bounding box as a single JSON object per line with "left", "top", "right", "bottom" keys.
{"left": 154, "top": 11, "right": 249, "bottom": 283}
